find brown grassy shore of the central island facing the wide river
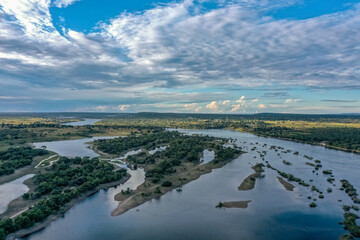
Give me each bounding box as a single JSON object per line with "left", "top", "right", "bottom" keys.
{"left": 111, "top": 152, "right": 243, "bottom": 216}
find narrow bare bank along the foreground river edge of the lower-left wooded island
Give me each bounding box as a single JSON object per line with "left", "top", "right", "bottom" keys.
{"left": 6, "top": 174, "right": 131, "bottom": 240}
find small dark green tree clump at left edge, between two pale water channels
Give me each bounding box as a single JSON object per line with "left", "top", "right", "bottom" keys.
{"left": 0, "top": 147, "right": 49, "bottom": 176}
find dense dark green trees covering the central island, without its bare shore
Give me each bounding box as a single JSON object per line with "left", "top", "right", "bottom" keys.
{"left": 96, "top": 130, "right": 240, "bottom": 186}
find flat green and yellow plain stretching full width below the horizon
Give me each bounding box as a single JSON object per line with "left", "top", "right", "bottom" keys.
{"left": 0, "top": 113, "right": 360, "bottom": 152}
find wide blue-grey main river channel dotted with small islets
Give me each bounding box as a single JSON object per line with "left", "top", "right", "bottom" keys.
{"left": 28, "top": 130, "right": 360, "bottom": 240}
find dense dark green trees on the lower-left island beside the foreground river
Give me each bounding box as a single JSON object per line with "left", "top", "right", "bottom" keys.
{"left": 0, "top": 157, "right": 126, "bottom": 239}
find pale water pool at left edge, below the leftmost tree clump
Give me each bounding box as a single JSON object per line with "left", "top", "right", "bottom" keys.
{"left": 0, "top": 174, "right": 34, "bottom": 213}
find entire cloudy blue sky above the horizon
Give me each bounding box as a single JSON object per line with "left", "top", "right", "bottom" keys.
{"left": 0, "top": 0, "right": 360, "bottom": 114}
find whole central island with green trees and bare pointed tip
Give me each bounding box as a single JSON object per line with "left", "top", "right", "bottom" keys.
{"left": 95, "top": 129, "right": 241, "bottom": 215}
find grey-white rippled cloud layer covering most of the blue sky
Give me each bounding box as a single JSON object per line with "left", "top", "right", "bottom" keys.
{"left": 0, "top": 0, "right": 360, "bottom": 112}
